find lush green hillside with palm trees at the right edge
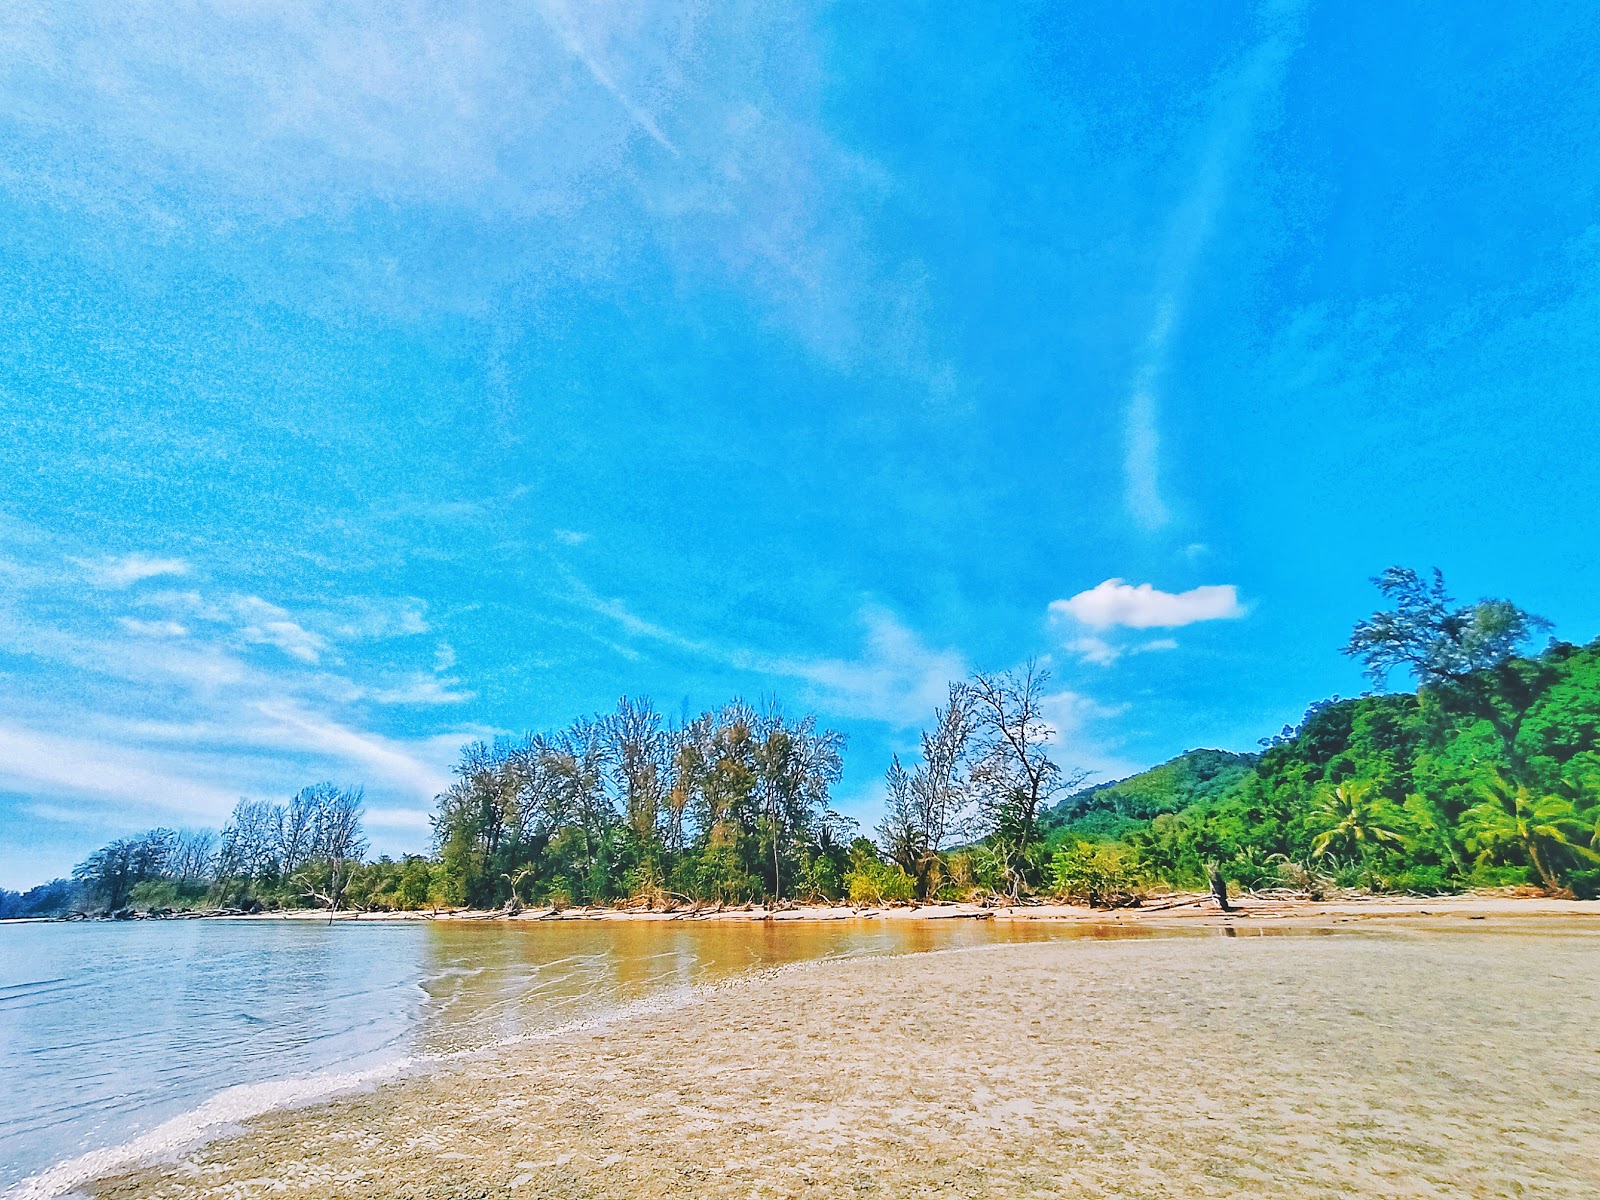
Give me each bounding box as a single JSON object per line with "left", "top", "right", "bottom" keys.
{"left": 1075, "top": 642, "right": 1600, "bottom": 896}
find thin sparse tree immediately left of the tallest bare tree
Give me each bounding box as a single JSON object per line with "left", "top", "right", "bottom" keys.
{"left": 877, "top": 683, "right": 973, "bottom": 899}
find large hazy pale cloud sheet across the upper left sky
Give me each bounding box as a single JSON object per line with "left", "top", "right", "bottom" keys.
{"left": 0, "top": 0, "right": 955, "bottom": 387}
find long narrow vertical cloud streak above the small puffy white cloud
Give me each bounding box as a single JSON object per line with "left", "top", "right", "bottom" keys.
{"left": 1123, "top": 3, "right": 1301, "bottom": 533}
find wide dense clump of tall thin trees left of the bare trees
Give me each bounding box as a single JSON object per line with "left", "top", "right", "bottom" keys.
{"left": 434, "top": 698, "right": 853, "bottom": 907}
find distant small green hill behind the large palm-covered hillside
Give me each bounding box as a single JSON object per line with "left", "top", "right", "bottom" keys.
{"left": 1040, "top": 750, "right": 1261, "bottom": 842}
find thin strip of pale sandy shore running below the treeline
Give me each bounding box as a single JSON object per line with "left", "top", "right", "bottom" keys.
{"left": 9, "top": 893, "right": 1600, "bottom": 928}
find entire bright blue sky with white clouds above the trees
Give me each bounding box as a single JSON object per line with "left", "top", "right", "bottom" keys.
{"left": 0, "top": 0, "right": 1600, "bottom": 888}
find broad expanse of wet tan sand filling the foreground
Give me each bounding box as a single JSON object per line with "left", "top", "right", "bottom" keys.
{"left": 91, "top": 915, "right": 1600, "bottom": 1200}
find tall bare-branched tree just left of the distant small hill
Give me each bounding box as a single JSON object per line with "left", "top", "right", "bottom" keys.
{"left": 968, "top": 659, "right": 1088, "bottom": 896}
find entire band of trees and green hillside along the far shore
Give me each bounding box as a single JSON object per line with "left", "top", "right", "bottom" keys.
{"left": 34, "top": 568, "right": 1600, "bottom": 915}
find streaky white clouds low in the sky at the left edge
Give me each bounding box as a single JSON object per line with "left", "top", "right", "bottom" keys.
{"left": 0, "top": 534, "right": 483, "bottom": 830}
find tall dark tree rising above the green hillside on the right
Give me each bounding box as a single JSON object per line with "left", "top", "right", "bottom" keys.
{"left": 1344, "top": 566, "right": 1554, "bottom": 778}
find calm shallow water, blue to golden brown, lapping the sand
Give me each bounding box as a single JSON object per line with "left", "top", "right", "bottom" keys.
{"left": 0, "top": 920, "right": 1088, "bottom": 1190}
